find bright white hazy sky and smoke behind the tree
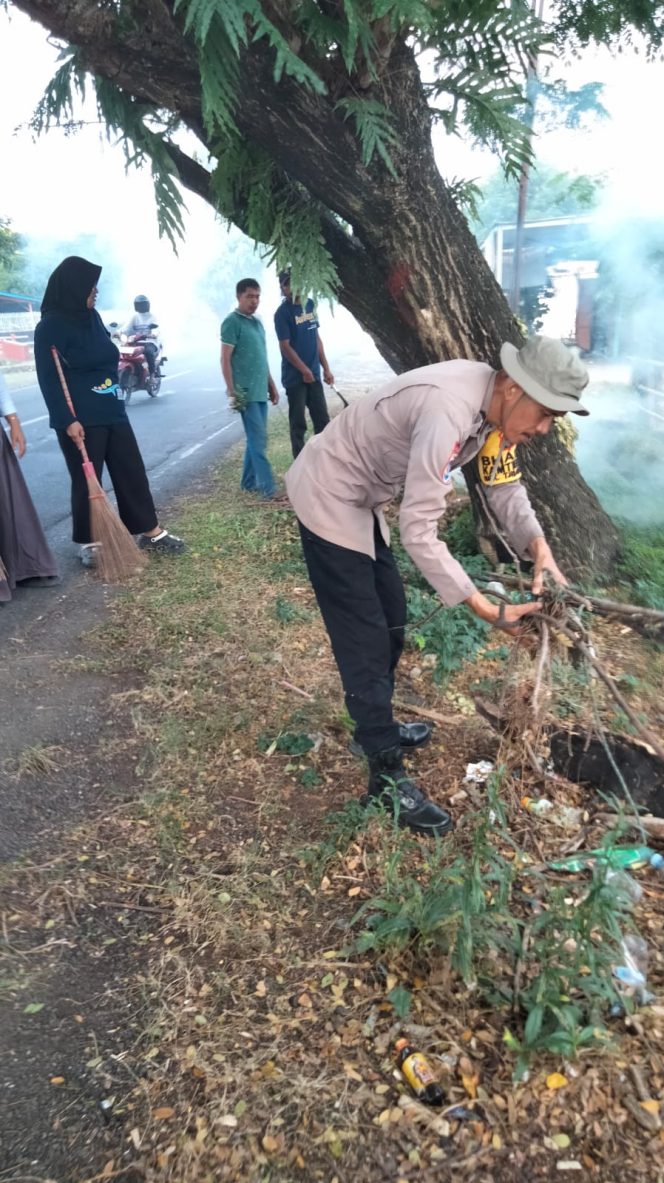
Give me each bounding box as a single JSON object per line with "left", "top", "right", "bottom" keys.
{"left": 0, "top": 11, "right": 664, "bottom": 524}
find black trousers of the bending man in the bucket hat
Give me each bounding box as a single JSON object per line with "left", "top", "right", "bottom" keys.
{"left": 298, "top": 522, "right": 406, "bottom": 755}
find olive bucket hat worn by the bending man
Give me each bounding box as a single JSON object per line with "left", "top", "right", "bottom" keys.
{"left": 501, "top": 336, "right": 589, "bottom": 415}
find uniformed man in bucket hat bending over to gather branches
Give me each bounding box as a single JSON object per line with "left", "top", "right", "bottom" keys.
{"left": 285, "top": 337, "right": 588, "bottom": 835}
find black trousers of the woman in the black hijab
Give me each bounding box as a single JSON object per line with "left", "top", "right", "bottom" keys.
{"left": 57, "top": 421, "right": 159, "bottom": 543}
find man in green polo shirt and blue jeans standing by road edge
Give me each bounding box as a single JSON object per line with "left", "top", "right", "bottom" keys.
{"left": 221, "top": 279, "right": 279, "bottom": 500}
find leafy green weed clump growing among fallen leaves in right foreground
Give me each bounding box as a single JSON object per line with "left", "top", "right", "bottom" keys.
{"left": 353, "top": 774, "right": 628, "bottom": 1078}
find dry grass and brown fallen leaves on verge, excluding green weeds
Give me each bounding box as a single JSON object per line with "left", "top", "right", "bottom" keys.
{"left": 1, "top": 411, "right": 664, "bottom": 1183}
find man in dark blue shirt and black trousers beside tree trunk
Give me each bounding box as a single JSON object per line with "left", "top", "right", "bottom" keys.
{"left": 275, "top": 271, "right": 334, "bottom": 457}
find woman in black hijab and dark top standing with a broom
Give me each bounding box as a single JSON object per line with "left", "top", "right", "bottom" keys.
{"left": 34, "top": 256, "right": 185, "bottom": 567}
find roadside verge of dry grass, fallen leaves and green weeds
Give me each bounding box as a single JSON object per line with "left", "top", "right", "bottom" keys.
{"left": 2, "top": 419, "right": 664, "bottom": 1183}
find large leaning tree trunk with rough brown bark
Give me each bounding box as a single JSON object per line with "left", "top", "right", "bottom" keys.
{"left": 14, "top": 0, "right": 617, "bottom": 577}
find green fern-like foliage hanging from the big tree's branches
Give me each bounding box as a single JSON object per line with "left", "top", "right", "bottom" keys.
{"left": 17, "top": 0, "right": 664, "bottom": 300}
